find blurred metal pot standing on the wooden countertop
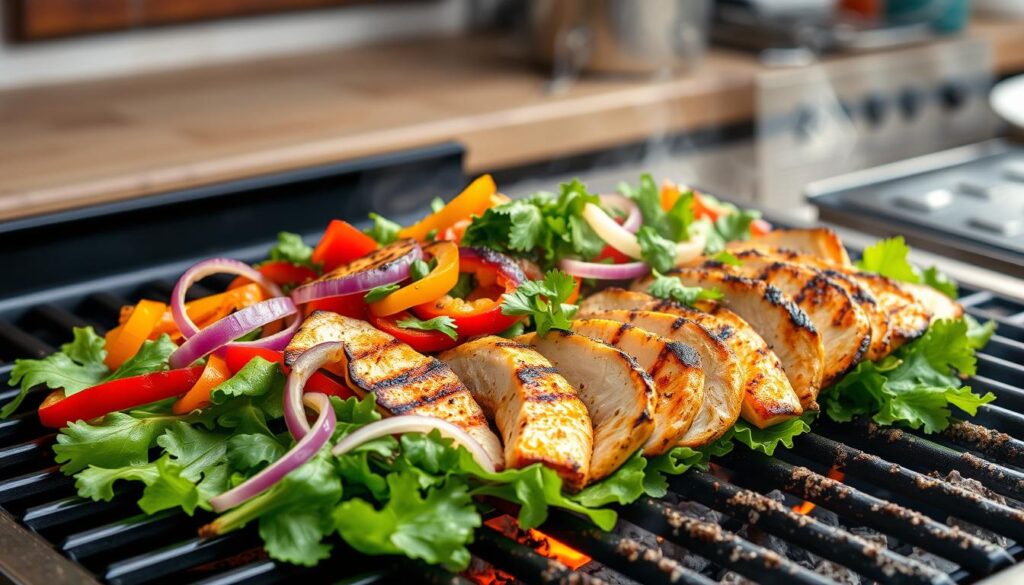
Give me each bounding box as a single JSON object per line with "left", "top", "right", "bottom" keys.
{"left": 528, "top": 0, "right": 711, "bottom": 75}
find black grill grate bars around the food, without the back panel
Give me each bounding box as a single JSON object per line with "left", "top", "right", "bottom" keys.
{"left": 0, "top": 147, "right": 1024, "bottom": 585}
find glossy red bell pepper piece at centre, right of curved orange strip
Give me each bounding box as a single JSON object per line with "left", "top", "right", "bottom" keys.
{"left": 412, "top": 252, "right": 521, "bottom": 339}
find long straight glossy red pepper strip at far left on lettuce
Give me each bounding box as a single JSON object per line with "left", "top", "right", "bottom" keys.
{"left": 39, "top": 366, "right": 203, "bottom": 428}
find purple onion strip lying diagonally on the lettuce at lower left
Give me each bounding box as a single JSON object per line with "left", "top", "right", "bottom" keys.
{"left": 210, "top": 392, "right": 337, "bottom": 513}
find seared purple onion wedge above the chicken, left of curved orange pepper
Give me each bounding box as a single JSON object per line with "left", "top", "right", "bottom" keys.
{"left": 292, "top": 240, "right": 423, "bottom": 304}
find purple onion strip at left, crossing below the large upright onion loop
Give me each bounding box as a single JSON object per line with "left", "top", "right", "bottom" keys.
{"left": 168, "top": 296, "right": 299, "bottom": 369}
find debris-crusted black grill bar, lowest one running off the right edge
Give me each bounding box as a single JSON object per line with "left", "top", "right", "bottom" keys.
{"left": 776, "top": 432, "right": 1024, "bottom": 545}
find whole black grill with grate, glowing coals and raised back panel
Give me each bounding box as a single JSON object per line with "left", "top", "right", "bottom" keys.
{"left": 0, "top": 145, "right": 1024, "bottom": 585}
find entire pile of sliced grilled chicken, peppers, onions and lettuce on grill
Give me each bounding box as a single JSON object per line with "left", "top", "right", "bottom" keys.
{"left": 0, "top": 175, "right": 994, "bottom": 571}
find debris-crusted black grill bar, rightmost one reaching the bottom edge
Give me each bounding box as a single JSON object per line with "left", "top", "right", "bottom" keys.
{"left": 671, "top": 470, "right": 958, "bottom": 584}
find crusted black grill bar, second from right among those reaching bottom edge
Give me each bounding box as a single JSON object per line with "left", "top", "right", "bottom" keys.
{"left": 622, "top": 497, "right": 833, "bottom": 585}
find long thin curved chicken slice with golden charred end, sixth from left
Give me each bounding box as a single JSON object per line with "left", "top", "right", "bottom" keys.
{"left": 579, "top": 288, "right": 804, "bottom": 428}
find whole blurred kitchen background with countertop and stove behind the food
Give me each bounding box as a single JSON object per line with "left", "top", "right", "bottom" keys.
{"left": 0, "top": 0, "right": 1024, "bottom": 296}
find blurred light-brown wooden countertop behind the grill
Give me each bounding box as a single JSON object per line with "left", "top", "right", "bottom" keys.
{"left": 0, "top": 23, "right": 1024, "bottom": 219}
